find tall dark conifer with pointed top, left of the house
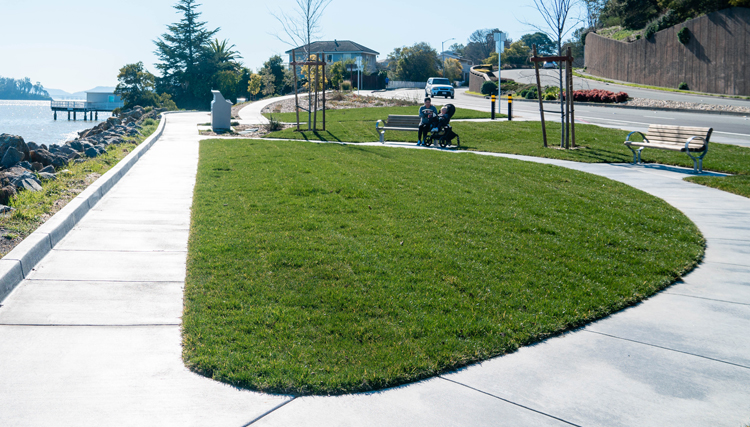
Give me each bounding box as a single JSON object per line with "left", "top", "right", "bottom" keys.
{"left": 154, "top": 0, "right": 219, "bottom": 108}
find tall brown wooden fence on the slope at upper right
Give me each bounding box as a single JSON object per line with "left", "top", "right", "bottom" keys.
{"left": 586, "top": 7, "right": 750, "bottom": 95}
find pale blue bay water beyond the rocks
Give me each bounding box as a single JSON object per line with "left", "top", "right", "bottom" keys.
{"left": 0, "top": 100, "right": 110, "bottom": 146}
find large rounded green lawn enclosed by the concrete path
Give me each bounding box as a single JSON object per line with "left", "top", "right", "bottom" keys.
{"left": 183, "top": 140, "right": 704, "bottom": 395}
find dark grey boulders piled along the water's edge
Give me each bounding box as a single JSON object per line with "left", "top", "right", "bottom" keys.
{"left": 0, "top": 107, "right": 164, "bottom": 208}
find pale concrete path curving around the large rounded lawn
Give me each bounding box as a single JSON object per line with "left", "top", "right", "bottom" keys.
{"left": 0, "top": 113, "right": 750, "bottom": 427}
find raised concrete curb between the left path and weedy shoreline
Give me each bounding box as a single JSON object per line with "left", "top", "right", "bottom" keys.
{"left": 0, "top": 113, "right": 168, "bottom": 302}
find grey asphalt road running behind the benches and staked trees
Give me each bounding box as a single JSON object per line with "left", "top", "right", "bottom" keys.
{"left": 362, "top": 86, "right": 750, "bottom": 147}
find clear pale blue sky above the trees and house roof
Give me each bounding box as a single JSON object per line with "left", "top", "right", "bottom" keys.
{"left": 0, "top": 0, "right": 588, "bottom": 93}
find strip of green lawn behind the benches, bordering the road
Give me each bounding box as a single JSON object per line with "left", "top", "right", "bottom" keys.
{"left": 267, "top": 107, "right": 750, "bottom": 197}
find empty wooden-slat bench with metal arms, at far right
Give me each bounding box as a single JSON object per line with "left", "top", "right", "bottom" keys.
{"left": 625, "top": 125, "right": 714, "bottom": 173}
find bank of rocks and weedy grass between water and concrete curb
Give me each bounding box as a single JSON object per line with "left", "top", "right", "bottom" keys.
{"left": 0, "top": 107, "right": 161, "bottom": 256}
